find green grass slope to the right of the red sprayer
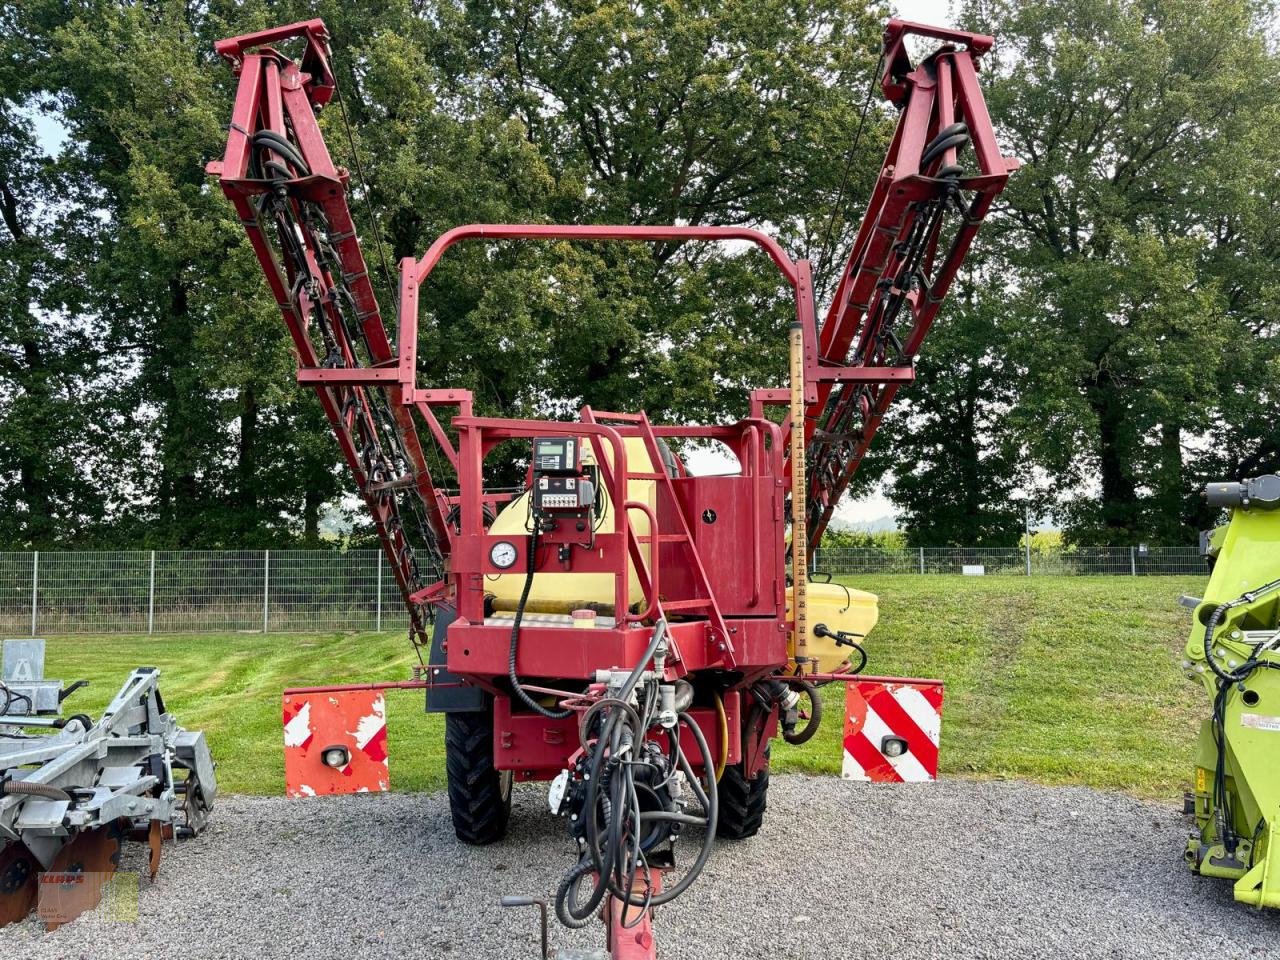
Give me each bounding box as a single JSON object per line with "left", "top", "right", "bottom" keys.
{"left": 776, "top": 576, "right": 1210, "bottom": 797}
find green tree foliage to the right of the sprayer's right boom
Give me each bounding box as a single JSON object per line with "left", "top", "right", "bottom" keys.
{"left": 875, "top": 0, "right": 1280, "bottom": 544}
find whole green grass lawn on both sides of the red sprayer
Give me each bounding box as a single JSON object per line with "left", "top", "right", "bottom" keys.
{"left": 35, "top": 575, "right": 1208, "bottom": 797}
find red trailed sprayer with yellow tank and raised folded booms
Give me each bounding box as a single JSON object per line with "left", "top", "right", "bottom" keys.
{"left": 209, "top": 20, "right": 1016, "bottom": 956}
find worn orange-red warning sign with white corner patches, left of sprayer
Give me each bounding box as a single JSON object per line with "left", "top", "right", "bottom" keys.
{"left": 284, "top": 690, "right": 390, "bottom": 796}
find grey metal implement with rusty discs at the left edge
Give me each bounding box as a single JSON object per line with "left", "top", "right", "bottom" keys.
{"left": 0, "top": 650, "right": 218, "bottom": 927}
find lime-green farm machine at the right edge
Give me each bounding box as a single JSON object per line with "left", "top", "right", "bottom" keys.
{"left": 1183, "top": 475, "right": 1280, "bottom": 908}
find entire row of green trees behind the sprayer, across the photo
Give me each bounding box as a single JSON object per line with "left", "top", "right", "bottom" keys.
{"left": 0, "top": 0, "right": 1280, "bottom": 547}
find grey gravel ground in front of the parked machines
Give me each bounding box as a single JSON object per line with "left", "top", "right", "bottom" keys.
{"left": 0, "top": 776, "right": 1280, "bottom": 960}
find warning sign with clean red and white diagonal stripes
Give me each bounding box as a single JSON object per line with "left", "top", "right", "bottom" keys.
{"left": 841, "top": 677, "right": 942, "bottom": 783}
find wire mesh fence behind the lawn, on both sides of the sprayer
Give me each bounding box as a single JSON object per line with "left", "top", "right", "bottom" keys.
{"left": 0, "top": 547, "right": 1204, "bottom": 636}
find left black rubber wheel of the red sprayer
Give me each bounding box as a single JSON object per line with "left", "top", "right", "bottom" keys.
{"left": 444, "top": 703, "right": 511, "bottom": 846}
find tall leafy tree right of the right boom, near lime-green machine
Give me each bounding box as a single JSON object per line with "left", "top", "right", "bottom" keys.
{"left": 963, "top": 0, "right": 1280, "bottom": 543}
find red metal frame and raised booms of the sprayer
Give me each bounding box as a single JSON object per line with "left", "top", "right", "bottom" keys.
{"left": 209, "top": 20, "right": 1016, "bottom": 960}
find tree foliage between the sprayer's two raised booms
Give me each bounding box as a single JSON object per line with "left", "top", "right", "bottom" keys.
{"left": 355, "top": 0, "right": 881, "bottom": 437}
